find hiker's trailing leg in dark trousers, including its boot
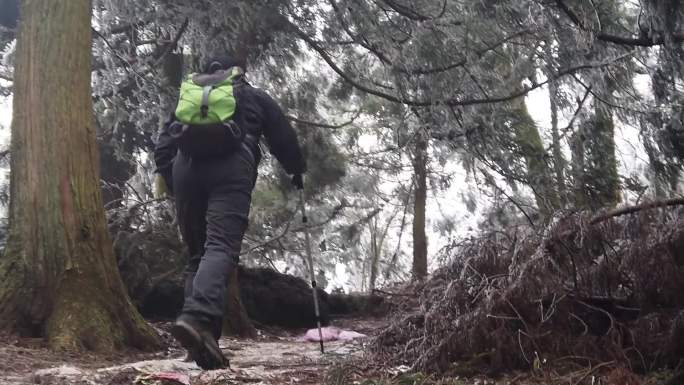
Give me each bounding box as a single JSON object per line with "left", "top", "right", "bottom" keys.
{"left": 172, "top": 148, "right": 254, "bottom": 369}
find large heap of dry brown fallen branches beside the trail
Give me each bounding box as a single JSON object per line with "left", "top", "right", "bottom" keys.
{"left": 372, "top": 206, "right": 684, "bottom": 374}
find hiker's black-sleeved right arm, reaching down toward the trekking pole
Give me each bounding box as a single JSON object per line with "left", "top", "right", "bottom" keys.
{"left": 258, "top": 91, "right": 306, "bottom": 175}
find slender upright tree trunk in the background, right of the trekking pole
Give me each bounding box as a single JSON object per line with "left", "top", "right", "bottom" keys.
{"left": 412, "top": 136, "right": 428, "bottom": 281}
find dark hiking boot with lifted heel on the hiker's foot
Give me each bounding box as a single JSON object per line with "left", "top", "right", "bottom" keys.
{"left": 171, "top": 314, "right": 228, "bottom": 370}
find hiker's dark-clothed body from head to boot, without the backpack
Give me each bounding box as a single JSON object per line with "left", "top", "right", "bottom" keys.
{"left": 154, "top": 57, "right": 306, "bottom": 369}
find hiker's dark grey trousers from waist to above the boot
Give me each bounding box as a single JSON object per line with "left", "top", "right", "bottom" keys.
{"left": 173, "top": 148, "right": 257, "bottom": 338}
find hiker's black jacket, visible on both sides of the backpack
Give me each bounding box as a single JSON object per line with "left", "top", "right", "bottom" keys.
{"left": 154, "top": 77, "right": 306, "bottom": 185}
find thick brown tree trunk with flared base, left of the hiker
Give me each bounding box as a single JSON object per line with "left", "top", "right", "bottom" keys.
{"left": 0, "top": 0, "right": 160, "bottom": 352}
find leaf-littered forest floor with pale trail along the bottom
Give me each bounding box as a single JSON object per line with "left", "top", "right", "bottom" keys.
{"left": 0, "top": 319, "right": 670, "bottom": 385}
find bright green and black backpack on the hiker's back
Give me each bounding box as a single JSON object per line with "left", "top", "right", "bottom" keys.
{"left": 169, "top": 67, "right": 245, "bottom": 158}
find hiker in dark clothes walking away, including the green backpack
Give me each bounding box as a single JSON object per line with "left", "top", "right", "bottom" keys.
{"left": 154, "top": 55, "right": 306, "bottom": 369}
